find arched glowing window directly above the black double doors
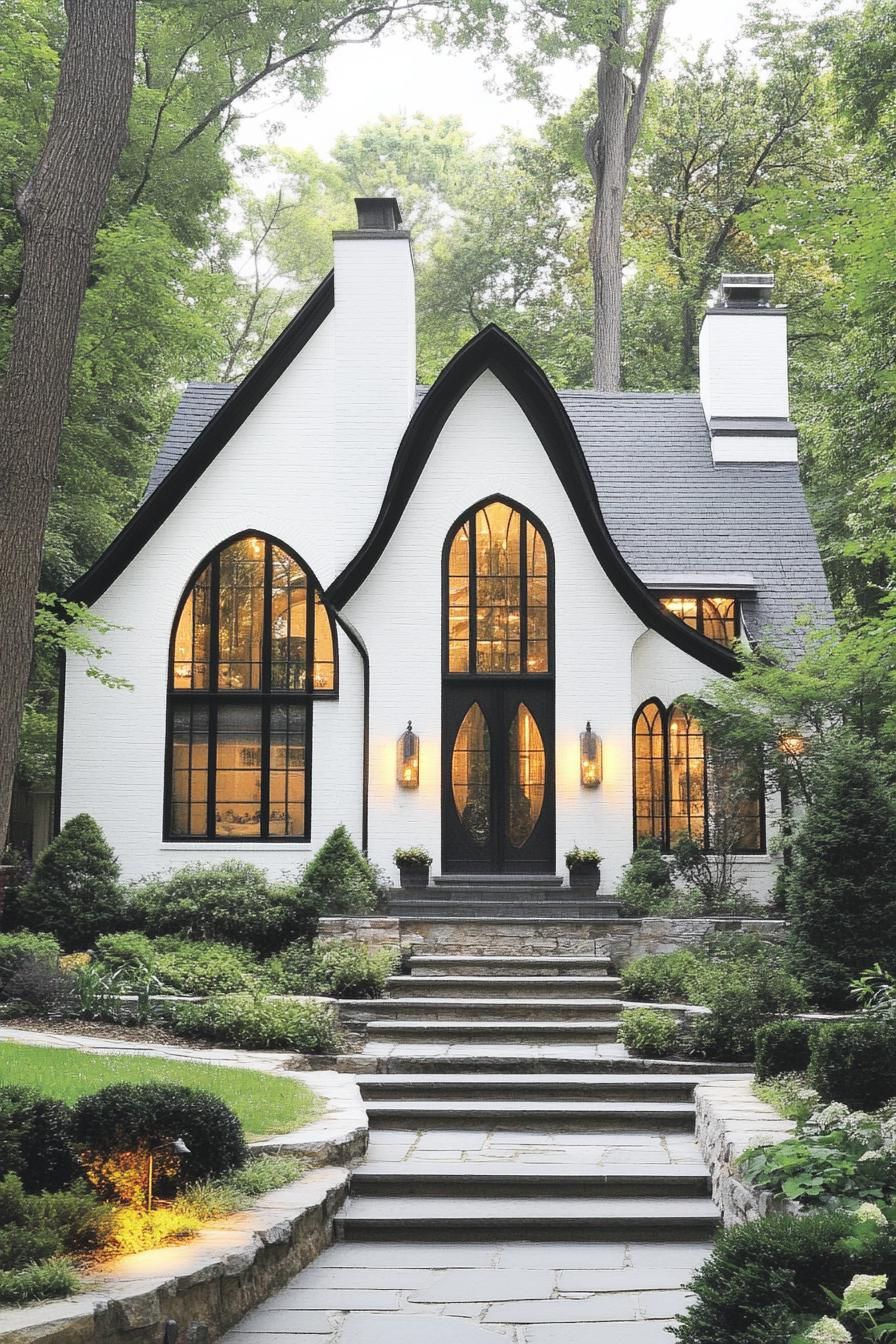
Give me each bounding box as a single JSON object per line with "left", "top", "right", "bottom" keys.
{"left": 445, "top": 500, "right": 552, "bottom": 676}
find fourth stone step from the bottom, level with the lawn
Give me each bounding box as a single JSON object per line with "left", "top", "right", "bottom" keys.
{"left": 357, "top": 1073, "right": 699, "bottom": 1102}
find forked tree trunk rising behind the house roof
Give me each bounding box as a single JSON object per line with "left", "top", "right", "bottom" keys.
{"left": 584, "top": 0, "right": 672, "bottom": 392}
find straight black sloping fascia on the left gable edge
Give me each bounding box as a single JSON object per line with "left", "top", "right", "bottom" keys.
{"left": 66, "top": 271, "right": 334, "bottom": 605}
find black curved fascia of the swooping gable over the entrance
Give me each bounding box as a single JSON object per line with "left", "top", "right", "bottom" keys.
{"left": 325, "top": 325, "right": 739, "bottom": 676}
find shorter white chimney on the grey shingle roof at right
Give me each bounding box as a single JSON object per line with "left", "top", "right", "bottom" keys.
{"left": 700, "top": 276, "right": 797, "bottom": 464}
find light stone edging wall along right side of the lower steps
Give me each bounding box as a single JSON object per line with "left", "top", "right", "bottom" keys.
{"left": 695, "top": 1074, "right": 799, "bottom": 1227}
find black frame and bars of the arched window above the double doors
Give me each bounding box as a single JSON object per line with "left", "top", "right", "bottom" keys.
{"left": 442, "top": 495, "right": 555, "bottom": 681}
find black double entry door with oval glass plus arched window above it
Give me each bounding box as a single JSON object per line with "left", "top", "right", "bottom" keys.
{"left": 442, "top": 499, "right": 555, "bottom": 874}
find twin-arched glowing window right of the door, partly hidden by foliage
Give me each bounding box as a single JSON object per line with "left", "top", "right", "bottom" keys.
{"left": 633, "top": 700, "right": 764, "bottom": 853}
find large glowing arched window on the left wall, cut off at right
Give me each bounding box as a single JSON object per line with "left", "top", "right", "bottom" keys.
{"left": 164, "top": 535, "right": 337, "bottom": 840}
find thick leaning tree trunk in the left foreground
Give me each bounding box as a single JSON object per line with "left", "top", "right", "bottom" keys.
{"left": 0, "top": 0, "right": 136, "bottom": 840}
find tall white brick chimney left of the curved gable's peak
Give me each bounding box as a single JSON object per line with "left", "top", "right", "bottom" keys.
{"left": 333, "top": 196, "right": 416, "bottom": 546}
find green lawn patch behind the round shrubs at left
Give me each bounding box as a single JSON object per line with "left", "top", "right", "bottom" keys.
{"left": 0, "top": 1042, "right": 321, "bottom": 1140}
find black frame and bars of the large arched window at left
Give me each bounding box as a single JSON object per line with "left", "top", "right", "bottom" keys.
{"left": 163, "top": 528, "right": 339, "bottom": 845}
